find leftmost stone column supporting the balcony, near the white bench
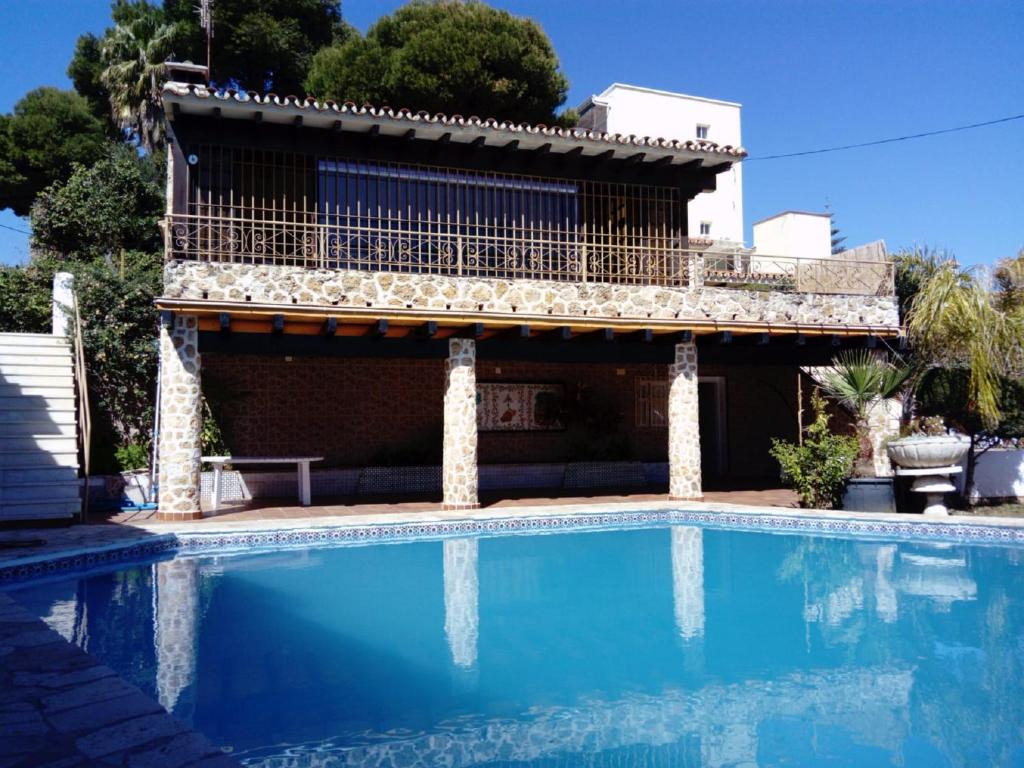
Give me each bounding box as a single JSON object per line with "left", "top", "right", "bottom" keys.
{"left": 158, "top": 315, "right": 203, "bottom": 520}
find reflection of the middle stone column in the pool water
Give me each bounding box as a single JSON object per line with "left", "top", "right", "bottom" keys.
{"left": 443, "top": 539, "right": 480, "bottom": 669}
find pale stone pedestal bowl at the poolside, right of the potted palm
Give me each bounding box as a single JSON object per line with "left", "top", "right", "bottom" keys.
{"left": 887, "top": 435, "right": 971, "bottom": 515}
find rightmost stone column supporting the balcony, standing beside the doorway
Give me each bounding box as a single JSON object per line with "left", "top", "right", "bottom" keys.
{"left": 669, "top": 341, "right": 703, "bottom": 500}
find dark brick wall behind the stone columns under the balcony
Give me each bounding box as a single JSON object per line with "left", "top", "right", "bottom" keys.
{"left": 203, "top": 353, "right": 796, "bottom": 476}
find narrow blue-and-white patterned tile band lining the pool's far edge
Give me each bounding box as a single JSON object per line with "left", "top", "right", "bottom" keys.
{"left": 0, "top": 505, "right": 1024, "bottom": 585}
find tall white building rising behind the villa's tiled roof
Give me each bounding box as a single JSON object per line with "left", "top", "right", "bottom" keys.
{"left": 580, "top": 83, "right": 743, "bottom": 243}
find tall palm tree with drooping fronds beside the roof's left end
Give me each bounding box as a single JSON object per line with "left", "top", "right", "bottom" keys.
{"left": 100, "top": 0, "right": 182, "bottom": 152}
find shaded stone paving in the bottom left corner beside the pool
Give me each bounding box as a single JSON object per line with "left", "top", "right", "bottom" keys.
{"left": 0, "top": 593, "right": 239, "bottom": 768}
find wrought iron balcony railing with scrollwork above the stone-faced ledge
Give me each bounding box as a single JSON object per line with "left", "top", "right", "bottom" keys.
{"left": 166, "top": 215, "right": 894, "bottom": 296}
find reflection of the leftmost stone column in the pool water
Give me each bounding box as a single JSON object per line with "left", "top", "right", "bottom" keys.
{"left": 153, "top": 558, "right": 199, "bottom": 716}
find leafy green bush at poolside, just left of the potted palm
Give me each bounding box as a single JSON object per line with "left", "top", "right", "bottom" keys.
{"left": 769, "top": 390, "right": 859, "bottom": 509}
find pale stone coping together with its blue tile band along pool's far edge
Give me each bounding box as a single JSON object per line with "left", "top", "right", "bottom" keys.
{"left": 0, "top": 501, "right": 1024, "bottom": 586}
